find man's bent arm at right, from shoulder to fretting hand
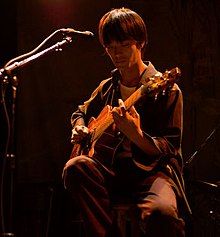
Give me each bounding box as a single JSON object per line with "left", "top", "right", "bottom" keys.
{"left": 113, "top": 86, "right": 182, "bottom": 159}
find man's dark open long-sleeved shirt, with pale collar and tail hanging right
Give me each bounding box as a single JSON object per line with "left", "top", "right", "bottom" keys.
{"left": 71, "top": 62, "right": 191, "bottom": 214}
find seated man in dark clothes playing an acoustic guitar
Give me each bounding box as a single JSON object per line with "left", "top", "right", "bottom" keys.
{"left": 63, "top": 8, "right": 188, "bottom": 237}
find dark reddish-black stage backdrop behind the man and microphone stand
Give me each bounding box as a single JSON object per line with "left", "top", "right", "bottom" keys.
{"left": 0, "top": 0, "right": 220, "bottom": 237}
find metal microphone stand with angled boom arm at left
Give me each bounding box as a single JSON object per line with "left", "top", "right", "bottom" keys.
{"left": 0, "top": 33, "right": 72, "bottom": 237}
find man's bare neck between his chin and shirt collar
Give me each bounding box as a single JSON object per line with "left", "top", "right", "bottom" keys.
{"left": 120, "top": 62, "right": 147, "bottom": 87}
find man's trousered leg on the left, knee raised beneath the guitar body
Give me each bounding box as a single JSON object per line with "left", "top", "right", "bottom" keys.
{"left": 63, "top": 156, "right": 120, "bottom": 237}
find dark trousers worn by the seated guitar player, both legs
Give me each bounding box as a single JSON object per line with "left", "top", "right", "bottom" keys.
{"left": 63, "top": 155, "right": 185, "bottom": 237}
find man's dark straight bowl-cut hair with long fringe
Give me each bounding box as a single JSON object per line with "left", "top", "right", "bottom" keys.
{"left": 99, "top": 8, "right": 147, "bottom": 46}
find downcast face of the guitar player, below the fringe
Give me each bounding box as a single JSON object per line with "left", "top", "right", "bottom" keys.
{"left": 105, "top": 40, "right": 141, "bottom": 70}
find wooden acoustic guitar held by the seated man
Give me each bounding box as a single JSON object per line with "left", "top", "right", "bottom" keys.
{"left": 70, "top": 67, "right": 181, "bottom": 167}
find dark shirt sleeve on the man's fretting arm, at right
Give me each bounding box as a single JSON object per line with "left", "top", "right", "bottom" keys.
{"left": 133, "top": 84, "right": 183, "bottom": 169}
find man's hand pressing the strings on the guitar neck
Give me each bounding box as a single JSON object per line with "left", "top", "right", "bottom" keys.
{"left": 112, "top": 99, "right": 142, "bottom": 140}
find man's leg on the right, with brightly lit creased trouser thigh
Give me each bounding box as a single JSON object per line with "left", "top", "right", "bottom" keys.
{"left": 137, "top": 178, "right": 185, "bottom": 237}
